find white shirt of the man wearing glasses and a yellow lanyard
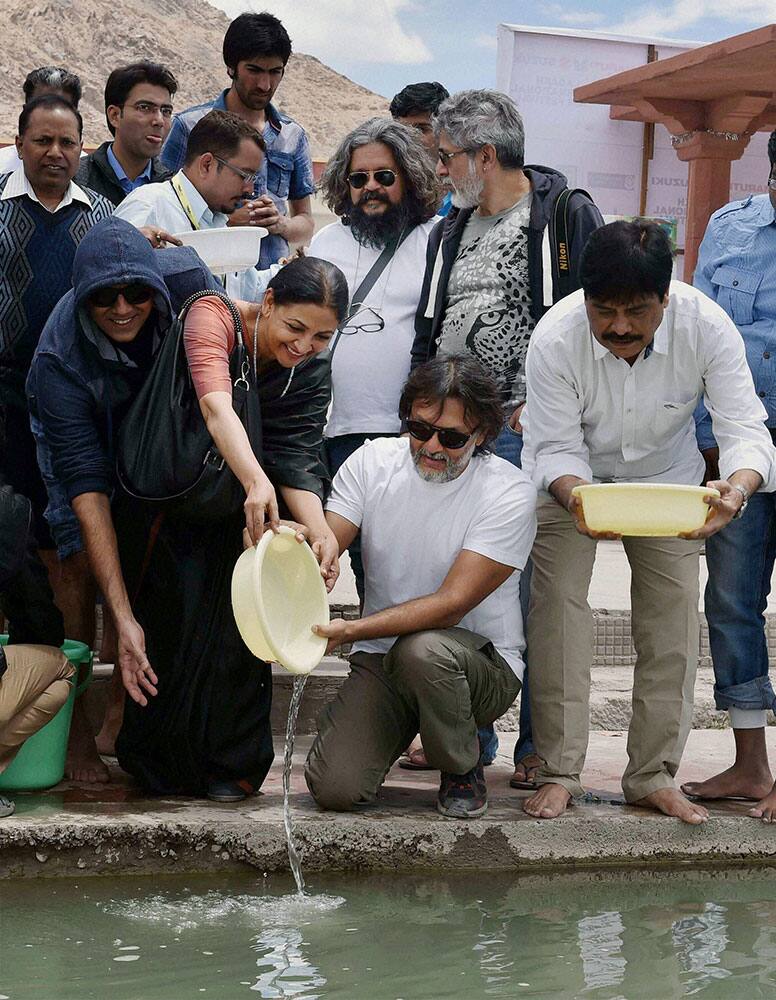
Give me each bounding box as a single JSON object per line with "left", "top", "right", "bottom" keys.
{"left": 113, "top": 170, "right": 268, "bottom": 302}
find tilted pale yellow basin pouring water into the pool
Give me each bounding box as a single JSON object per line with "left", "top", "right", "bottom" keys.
{"left": 232, "top": 526, "right": 329, "bottom": 674}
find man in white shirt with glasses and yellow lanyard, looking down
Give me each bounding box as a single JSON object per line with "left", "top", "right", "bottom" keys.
{"left": 114, "top": 111, "right": 271, "bottom": 302}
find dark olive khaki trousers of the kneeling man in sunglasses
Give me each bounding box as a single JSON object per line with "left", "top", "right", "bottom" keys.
{"left": 305, "top": 624, "right": 520, "bottom": 810}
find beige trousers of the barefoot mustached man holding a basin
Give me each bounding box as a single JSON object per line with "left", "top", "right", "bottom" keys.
{"left": 527, "top": 499, "right": 701, "bottom": 802}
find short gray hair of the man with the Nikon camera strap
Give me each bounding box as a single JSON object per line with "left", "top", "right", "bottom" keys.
{"left": 433, "top": 90, "right": 525, "bottom": 170}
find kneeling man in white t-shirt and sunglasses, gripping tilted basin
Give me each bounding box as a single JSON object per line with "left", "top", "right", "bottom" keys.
{"left": 305, "top": 354, "right": 536, "bottom": 819}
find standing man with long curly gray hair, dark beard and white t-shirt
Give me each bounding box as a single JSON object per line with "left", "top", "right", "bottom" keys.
{"left": 310, "top": 118, "right": 439, "bottom": 601}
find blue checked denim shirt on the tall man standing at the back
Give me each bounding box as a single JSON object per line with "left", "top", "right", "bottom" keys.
{"left": 161, "top": 90, "right": 315, "bottom": 270}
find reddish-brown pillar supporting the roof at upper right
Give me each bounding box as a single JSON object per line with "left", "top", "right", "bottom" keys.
{"left": 675, "top": 132, "right": 749, "bottom": 283}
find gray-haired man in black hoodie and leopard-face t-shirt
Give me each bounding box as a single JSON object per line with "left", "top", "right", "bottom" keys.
{"left": 412, "top": 90, "right": 603, "bottom": 788}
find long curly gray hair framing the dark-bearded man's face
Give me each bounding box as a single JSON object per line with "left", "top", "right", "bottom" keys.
{"left": 320, "top": 118, "right": 441, "bottom": 223}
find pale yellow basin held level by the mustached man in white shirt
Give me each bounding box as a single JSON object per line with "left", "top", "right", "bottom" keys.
{"left": 572, "top": 483, "right": 719, "bottom": 537}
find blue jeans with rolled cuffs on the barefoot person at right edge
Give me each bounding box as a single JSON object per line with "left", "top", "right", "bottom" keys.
{"left": 705, "top": 493, "right": 776, "bottom": 710}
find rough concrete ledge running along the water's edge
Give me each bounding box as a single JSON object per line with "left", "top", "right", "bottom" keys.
{"left": 0, "top": 792, "right": 776, "bottom": 877}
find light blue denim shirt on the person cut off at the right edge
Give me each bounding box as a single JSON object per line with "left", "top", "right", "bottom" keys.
{"left": 693, "top": 194, "right": 776, "bottom": 448}
